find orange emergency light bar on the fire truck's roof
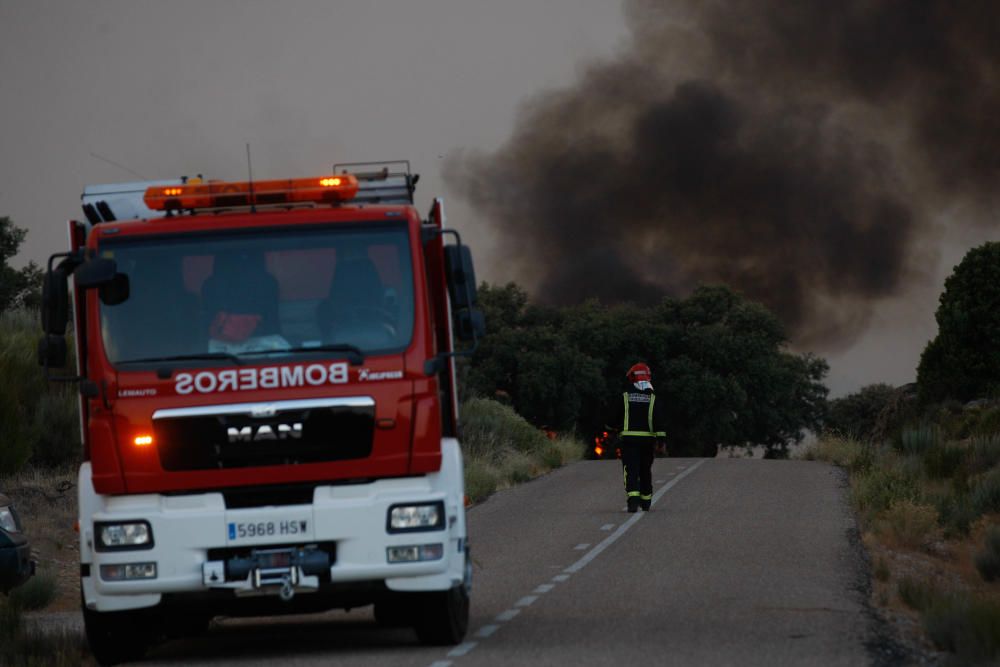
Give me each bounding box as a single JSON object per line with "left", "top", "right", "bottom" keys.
{"left": 142, "top": 174, "right": 358, "bottom": 211}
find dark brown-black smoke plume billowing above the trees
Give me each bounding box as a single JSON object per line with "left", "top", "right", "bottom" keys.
{"left": 445, "top": 0, "right": 1000, "bottom": 347}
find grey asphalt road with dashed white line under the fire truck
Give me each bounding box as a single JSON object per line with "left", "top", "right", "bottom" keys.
{"left": 129, "top": 459, "right": 896, "bottom": 667}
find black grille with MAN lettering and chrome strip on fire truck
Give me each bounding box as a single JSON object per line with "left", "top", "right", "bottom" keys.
{"left": 153, "top": 397, "right": 375, "bottom": 471}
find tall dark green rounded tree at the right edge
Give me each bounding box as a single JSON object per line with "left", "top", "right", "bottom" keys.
{"left": 917, "top": 242, "right": 1000, "bottom": 402}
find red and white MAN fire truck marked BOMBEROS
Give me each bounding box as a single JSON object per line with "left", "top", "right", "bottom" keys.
{"left": 39, "top": 163, "right": 483, "bottom": 663}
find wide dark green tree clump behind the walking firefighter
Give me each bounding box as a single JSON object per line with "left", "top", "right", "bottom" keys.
{"left": 467, "top": 283, "right": 827, "bottom": 456}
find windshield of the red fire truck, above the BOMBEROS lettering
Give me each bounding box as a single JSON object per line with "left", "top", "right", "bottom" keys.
{"left": 99, "top": 225, "right": 414, "bottom": 364}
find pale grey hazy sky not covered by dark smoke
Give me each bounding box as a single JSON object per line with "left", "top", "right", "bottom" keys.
{"left": 0, "top": 0, "right": 982, "bottom": 393}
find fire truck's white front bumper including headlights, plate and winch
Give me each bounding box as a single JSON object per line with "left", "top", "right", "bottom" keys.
{"left": 80, "top": 464, "right": 467, "bottom": 611}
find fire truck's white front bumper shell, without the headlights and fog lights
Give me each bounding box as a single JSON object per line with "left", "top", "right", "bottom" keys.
{"left": 80, "top": 445, "right": 467, "bottom": 611}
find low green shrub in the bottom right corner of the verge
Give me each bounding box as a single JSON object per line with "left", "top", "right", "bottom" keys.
{"left": 924, "top": 592, "right": 1000, "bottom": 664}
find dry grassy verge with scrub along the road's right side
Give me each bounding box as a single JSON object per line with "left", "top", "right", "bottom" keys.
{"left": 800, "top": 434, "right": 1000, "bottom": 664}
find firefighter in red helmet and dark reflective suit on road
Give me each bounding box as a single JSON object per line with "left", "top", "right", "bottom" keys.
{"left": 613, "top": 362, "right": 666, "bottom": 512}
